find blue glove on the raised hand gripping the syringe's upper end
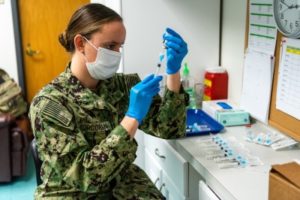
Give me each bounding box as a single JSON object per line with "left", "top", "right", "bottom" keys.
{"left": 163, "top": 28, "right": 188, "bottom": 74}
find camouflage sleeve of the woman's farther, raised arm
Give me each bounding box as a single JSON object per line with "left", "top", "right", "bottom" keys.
{"left": 140, "top": 86, "right": 189, "bottom": 139}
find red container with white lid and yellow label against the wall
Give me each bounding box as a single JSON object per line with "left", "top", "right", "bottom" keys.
{"left": 203, "top": 67, "right": 228, "bottom": 100}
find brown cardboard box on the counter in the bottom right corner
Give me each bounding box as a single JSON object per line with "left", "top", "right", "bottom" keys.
{"left": 269, "top": 162, "right": 300, "bottom": 200}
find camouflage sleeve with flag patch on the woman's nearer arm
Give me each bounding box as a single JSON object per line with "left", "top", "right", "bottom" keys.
{"left": 29, "top": 98, "right": 137, "bottom": 192}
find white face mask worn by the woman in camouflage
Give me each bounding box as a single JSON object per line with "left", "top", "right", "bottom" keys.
{"left": 85, "top": 38, "right": 121, "bottom": 80}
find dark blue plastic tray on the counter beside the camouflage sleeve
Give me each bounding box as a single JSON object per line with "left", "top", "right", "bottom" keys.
{"left": 186, "top": 109, "right": 224, "bottom": 136}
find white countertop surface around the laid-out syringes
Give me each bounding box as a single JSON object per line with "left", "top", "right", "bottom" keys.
{"left": 171, "top": 126, "right": 300, "bottom": 200}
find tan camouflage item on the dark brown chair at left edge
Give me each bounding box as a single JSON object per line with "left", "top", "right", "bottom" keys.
{"left": 0, "top": 69, "right": 27, "bottom": 117}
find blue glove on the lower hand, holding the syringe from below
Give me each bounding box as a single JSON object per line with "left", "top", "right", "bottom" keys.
{"left": 126, "top": 74, "right": 162, "bottom": 124}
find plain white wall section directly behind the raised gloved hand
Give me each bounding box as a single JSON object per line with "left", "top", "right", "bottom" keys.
{"left": 122, "top": 0, "right": 220, "bottom": 83}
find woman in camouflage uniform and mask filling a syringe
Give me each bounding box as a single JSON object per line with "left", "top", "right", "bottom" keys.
{"left": 29, "top": 4, "right": 188, "bottom": 200}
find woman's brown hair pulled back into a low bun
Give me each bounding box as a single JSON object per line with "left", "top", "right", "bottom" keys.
{"left": 58, "top": 3, "right": 123, "bottom": 53}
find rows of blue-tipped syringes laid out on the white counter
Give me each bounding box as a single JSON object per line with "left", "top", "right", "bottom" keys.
{"left": 198, "top": 134, "right": 263, "bottom": 169}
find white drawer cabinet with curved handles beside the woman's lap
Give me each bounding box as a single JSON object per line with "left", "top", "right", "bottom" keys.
{"left": 144, "top": 134, "right": 188, "bottom": 200}
